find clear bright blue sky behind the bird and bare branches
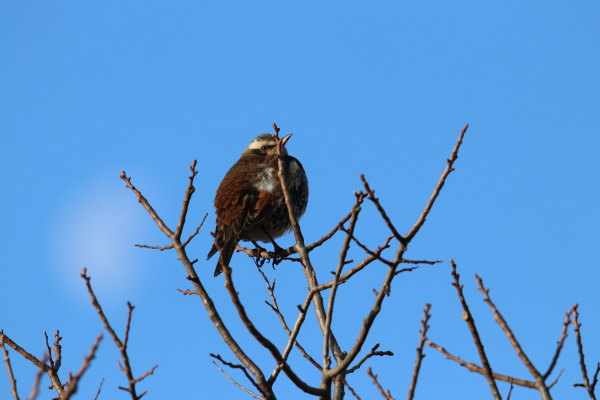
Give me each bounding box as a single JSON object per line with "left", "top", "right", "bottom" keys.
{"left": 0, "top": 0, "right": 600, "bottom": 399}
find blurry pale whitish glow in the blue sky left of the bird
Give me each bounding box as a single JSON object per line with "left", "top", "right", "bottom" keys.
{"left": 51, "top": 178, "right": 141, "bottom": 297}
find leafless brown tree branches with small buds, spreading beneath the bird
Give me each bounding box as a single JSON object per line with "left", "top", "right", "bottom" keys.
{"left": 0, "top": 124, "right": 600, "bottom": 400}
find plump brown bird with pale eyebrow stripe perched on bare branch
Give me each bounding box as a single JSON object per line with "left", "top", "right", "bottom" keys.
{"left": 207, "top": 133, "right": 308, "bottom": 276}
